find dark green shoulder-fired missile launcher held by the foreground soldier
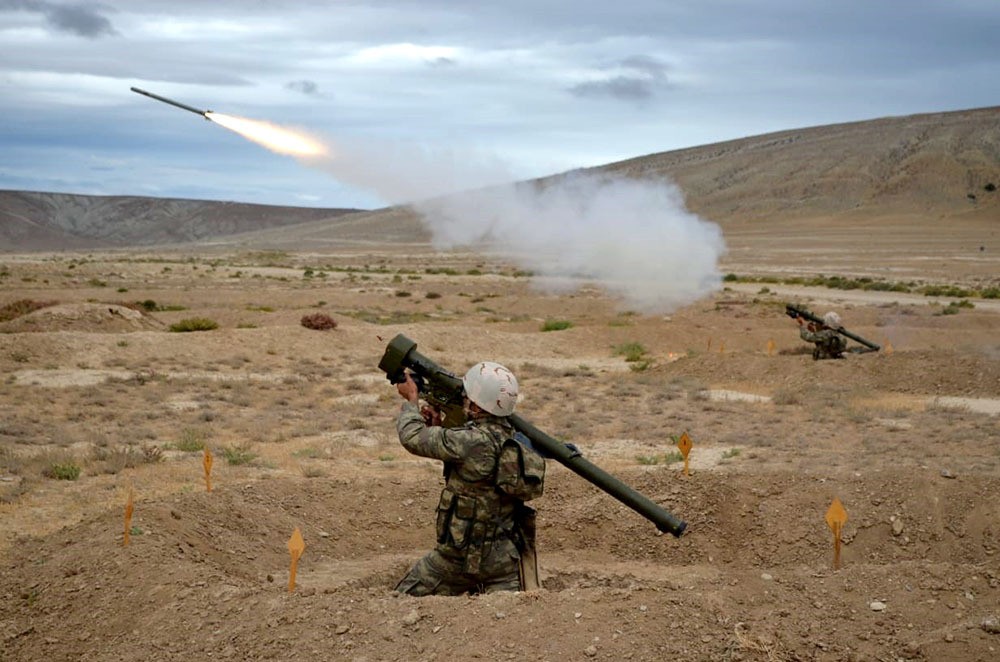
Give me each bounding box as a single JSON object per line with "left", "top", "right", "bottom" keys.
{"left": 378, "top": 334, "right": 687, "bottom": 538}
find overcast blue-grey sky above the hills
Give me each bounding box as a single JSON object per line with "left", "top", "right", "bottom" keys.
{"left": 0, "top": 0, "right": 1000, "bottom": 207}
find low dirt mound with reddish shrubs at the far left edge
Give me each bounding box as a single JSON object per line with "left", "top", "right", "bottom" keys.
{"left": 0, "top": 303, "right": 164, "bottom": 333}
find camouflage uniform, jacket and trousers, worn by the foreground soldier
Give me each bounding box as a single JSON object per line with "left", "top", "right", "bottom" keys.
{"left": 396, "top": 402, "right": 524, "bottom": 595}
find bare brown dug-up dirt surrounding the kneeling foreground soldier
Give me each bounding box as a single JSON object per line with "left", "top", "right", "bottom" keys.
{"left": 0, "top": 467, "right": 1000, "bottom": 662}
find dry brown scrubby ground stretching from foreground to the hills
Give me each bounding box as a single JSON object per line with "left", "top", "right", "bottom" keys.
{"left": 0, "top": 246, "right": 1000, "bottom": 662}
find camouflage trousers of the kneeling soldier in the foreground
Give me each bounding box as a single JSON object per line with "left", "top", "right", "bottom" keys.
{"left": 396, "top": 538, "right": 521, "bottom": 596}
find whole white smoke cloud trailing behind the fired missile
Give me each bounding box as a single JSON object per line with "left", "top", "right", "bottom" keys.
{"left": 296, "top": 143, "right": 725, "bottom": 313}
